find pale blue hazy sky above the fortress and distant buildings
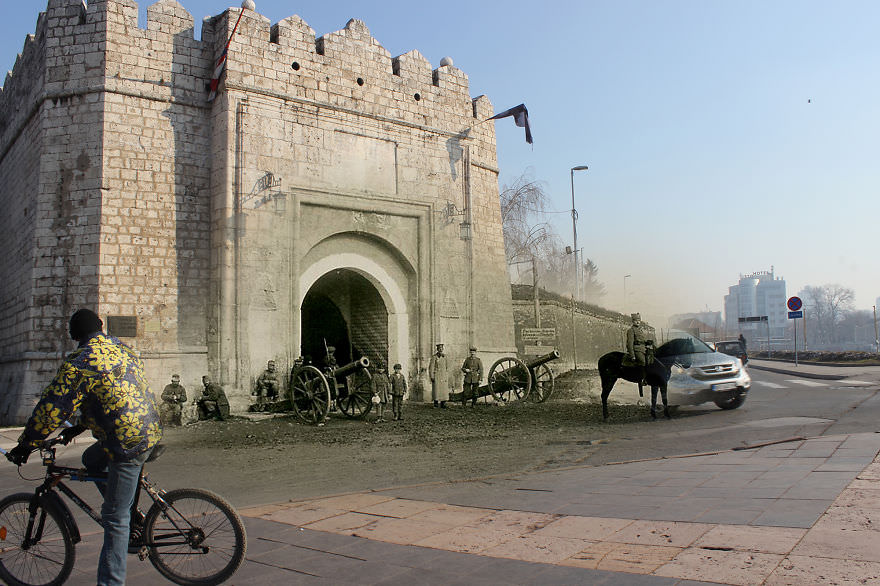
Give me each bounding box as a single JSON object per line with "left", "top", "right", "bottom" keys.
{"left": 0, "top": 0, "right": 880, "bottom": 325}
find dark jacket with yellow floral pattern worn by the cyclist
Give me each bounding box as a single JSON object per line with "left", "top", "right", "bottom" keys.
{"left": 19, "top": 333, "right": 162, "bottom": 460}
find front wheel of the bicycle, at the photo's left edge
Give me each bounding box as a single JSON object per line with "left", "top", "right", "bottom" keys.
{"left": 0, "top": 492, "right": 76, "bottom": 586}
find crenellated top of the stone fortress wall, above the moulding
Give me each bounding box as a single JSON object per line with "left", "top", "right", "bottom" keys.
{"left": 0, "top": 0, "right": 494, "bottom": 156}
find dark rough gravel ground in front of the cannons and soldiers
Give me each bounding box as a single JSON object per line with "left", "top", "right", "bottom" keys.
{"left": 151, "top": 392, "right": 672, "bottom": 506}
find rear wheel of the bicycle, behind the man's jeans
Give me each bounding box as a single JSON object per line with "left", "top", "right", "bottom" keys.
{"left": 144, "top": 488, "right": 247, "bottom": 586}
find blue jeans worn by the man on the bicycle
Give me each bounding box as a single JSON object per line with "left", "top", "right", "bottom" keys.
{"left": 82, "top": 443, "right": 152, "bottom": 586}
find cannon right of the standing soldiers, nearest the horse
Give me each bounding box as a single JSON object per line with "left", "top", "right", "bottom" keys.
{"left": 449, "top": 350, "right": 559, "bottom": 403}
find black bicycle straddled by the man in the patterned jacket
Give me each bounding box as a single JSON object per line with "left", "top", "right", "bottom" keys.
{"left": 0, "top": 436, "right": 247, "bottom": 586}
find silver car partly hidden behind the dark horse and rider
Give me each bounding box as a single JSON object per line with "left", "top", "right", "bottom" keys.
{"left": 654, "top": 330, "right": 752, "bottom": 409}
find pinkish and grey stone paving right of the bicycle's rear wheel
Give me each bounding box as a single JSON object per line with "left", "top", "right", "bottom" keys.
{"left": 243, "top": 434, "right": 880, "bottom": 585}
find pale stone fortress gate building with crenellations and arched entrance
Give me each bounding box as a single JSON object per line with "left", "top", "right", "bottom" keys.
{"left": 0, "top": 0, "right": 514, "bottom": 424}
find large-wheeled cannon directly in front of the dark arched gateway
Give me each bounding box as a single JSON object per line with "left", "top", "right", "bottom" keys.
{"left": 290, "top": 356, "right": 373, "bottom": 423}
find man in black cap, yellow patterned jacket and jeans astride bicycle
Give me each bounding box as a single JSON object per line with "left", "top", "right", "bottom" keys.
{"left": 6, "top": 309, "right": 162, "bottom": 585}
